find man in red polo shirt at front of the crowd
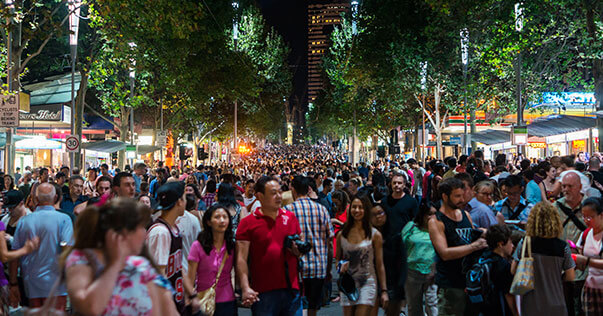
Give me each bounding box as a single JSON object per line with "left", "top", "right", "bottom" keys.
{"left": 236, "top": 176, "right": 302, "bottom": 316}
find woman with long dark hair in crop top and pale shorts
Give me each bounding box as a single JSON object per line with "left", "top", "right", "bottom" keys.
{"left": 336, "top": 195, "right": 389, "bottom": 316}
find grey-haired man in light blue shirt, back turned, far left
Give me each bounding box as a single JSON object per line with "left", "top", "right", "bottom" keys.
{"left": 9, "top": 181, "right": 74, "bottom": 309}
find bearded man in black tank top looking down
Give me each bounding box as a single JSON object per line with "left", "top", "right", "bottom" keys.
{"left": 428, "top": 178, "right": 488, "bottom": 315}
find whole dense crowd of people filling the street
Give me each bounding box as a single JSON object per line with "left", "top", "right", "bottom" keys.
{"left": 0, "top": 145, "right": 603, "bottom": 316}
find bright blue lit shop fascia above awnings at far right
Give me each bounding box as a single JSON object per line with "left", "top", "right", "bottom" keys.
{"left": 528, "top": 115, "right": 597, "bottom": 137}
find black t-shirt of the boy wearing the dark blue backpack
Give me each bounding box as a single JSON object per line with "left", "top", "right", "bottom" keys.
{"left": 482, "top": 252, "right": 513, "bottom": 316}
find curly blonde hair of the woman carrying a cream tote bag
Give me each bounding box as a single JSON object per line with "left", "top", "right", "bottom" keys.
{"left": 526, "top": 202, "right": 563, "bottom": 238}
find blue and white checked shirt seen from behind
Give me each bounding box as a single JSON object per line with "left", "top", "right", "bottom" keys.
{"left": 285, "top": 197, "right": 334, "bottom": 279}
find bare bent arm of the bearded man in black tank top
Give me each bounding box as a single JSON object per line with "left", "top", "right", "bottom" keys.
{"left": 428, "top": 218, "right": 488, "bottom": 261}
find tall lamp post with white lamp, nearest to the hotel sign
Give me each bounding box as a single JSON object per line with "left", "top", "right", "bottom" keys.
{"left": 67, "top": 0, "right": 83, "bottom": 170}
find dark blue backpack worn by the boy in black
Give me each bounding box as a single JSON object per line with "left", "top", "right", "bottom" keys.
{"left": 465, "top": 256, "right": 496, "bottom": 305}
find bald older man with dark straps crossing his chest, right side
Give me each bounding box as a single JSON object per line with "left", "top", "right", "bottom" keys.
{"left": 555, "top": 171, "right": 587, "bottom": 315}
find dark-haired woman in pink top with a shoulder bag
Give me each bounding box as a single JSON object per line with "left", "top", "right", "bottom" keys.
{"left": 188, "top": 204, "right": 237, "bottom": 316}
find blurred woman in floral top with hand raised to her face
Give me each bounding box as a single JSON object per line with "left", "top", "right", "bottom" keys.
{"left": 61, "top": 198, "right": 178, "bottom": 315}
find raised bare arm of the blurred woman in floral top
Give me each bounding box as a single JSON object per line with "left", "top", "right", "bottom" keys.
{"left": 65, "top": 230, "right": 129, "bottom": 315}
